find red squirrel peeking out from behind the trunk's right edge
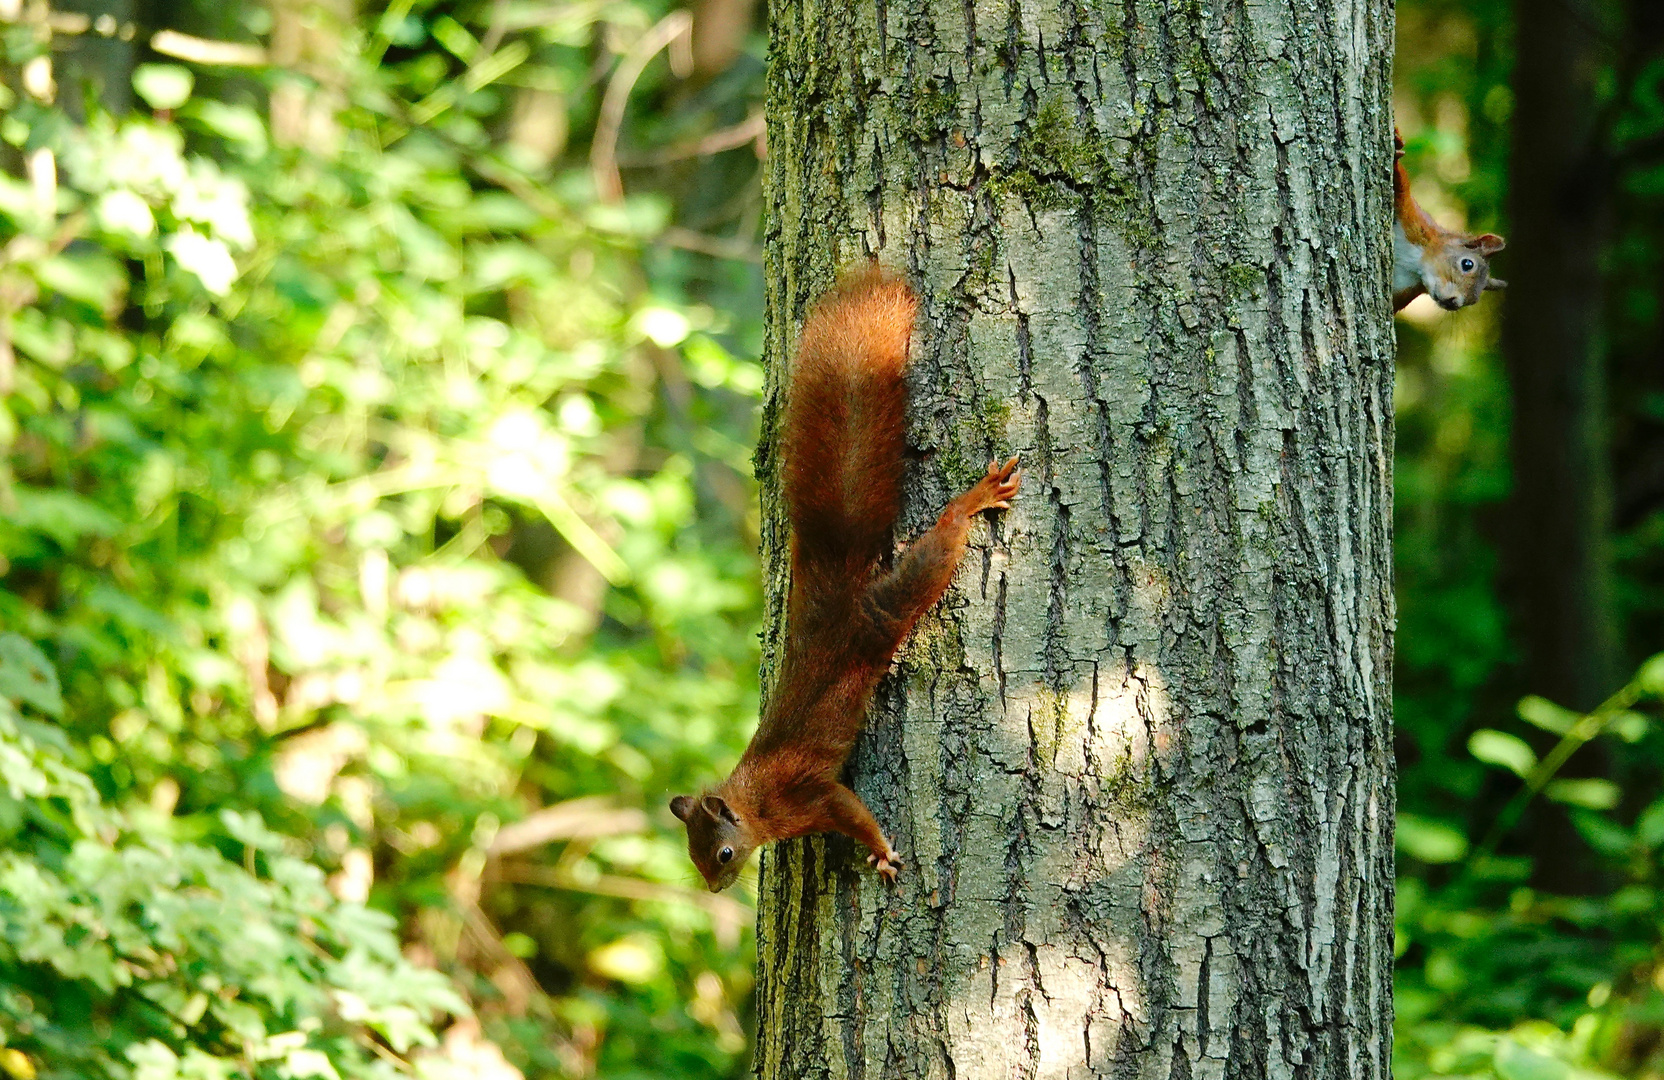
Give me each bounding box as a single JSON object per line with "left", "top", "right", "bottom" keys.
{"left": 1393, "top": 128, "right": 1508, "bottom": 311}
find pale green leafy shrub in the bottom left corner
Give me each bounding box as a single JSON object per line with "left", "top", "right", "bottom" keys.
{"left": 0, "top": 634, "right": 466, "bottom": 1080}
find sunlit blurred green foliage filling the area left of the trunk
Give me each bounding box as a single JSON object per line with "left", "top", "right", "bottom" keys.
{"left": 0, "top": 3, "right": 762, "bottom": 1078}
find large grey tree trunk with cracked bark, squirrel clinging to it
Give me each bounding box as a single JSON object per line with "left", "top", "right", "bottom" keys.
{"left": 757, "top": 0, "right": 1393, "bottom": 1080}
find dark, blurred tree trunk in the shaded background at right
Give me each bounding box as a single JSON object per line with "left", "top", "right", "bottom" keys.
{"left": 1503, "top": 0, "right": 1617, "bottom": 709}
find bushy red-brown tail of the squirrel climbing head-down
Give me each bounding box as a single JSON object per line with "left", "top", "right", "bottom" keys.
{"left": 782, "top": 268, "right": 915, "bottom": 589}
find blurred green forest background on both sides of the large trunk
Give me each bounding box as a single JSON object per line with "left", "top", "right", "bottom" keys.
{"left": 0, "top": 0, "right": 1664, "bottom": 1080}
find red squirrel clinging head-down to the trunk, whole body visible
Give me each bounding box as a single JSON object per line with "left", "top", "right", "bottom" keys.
{"left": 671, "top": 268, "right": 1022, "bottom": 892}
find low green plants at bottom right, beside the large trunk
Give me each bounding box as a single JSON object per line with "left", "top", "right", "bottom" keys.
{"left": 1394, "top": 654, "right": 1664, "bottom": 1080}
